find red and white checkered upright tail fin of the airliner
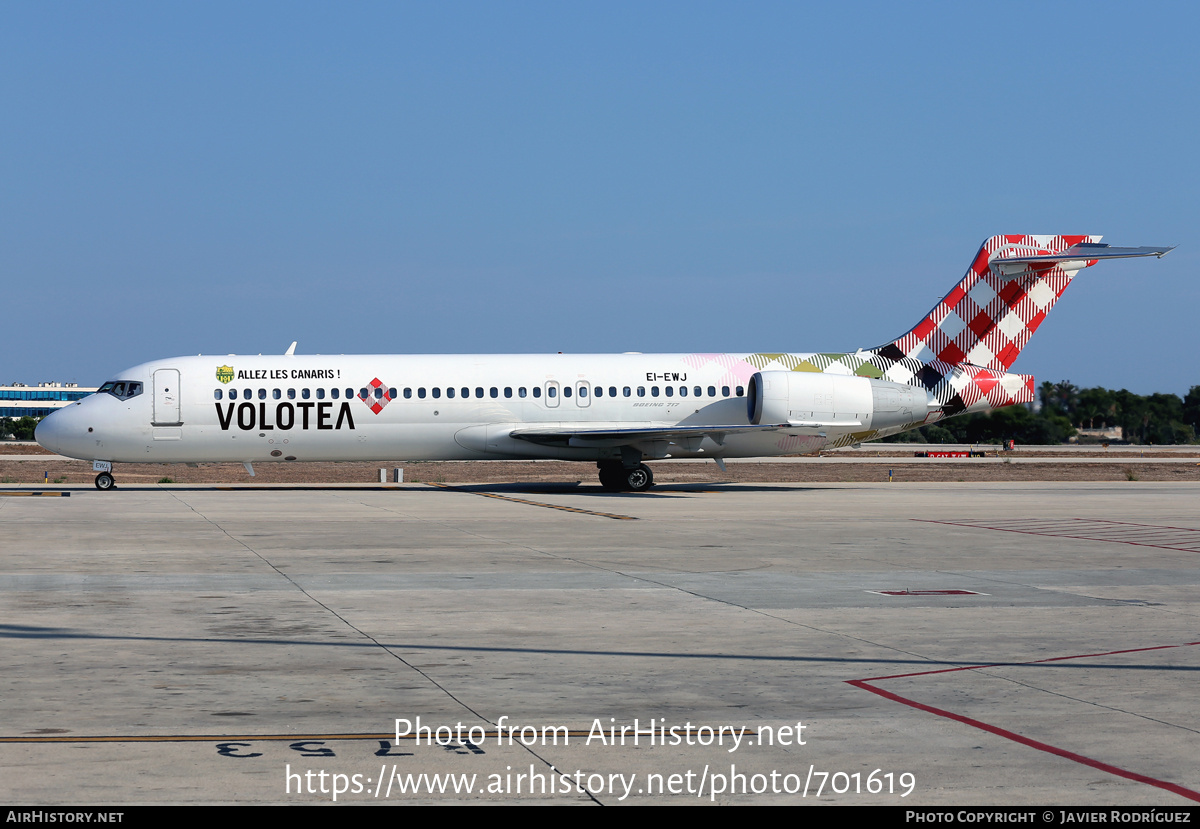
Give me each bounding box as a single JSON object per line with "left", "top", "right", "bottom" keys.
{"left": 875, "top": 235, "right": 1104, "bottom": 372}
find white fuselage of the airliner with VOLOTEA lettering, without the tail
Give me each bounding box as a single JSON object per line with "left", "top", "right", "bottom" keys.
{"left": 37, "top": 354, "right": 902, "bottom": 463}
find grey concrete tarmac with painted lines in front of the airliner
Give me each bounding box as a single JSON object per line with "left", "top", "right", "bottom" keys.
{"left": 0, "top": 481, "right": 1200, "bottom": 806}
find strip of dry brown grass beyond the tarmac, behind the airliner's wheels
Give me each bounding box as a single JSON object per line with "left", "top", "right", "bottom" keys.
{"left": 0, "top": 452, "right": 1200, "bottom": 485}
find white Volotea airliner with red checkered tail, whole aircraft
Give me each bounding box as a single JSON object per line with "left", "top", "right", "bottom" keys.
{"left": 37, "top": 235, "right": 1174, "bottom": 491}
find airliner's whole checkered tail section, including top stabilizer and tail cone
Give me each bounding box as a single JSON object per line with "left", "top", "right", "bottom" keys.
{"left": 866, "top": 235, "right": 1175, "bottom": 422}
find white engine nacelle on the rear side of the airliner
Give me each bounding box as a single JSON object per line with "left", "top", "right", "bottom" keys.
{"left": 746, "top": 371, "right": 937, "bottom": 429}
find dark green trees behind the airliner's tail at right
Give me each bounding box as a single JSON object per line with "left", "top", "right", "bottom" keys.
{"left": 884, "top": 380, "right": 1200, "bottom": 444}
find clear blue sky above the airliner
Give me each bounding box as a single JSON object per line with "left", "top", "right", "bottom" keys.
{"left": 0, "top": 2, "right": 1200, "bottom": 394}
